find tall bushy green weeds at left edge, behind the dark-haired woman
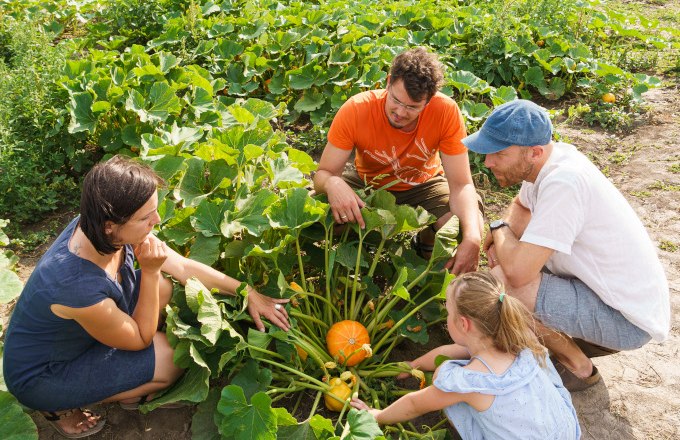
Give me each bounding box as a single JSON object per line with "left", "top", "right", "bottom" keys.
{"left": 0, "top": 19, "right": 82, "bottom": 222}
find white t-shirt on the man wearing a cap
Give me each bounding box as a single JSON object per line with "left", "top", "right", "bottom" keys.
{"left": 519, "top": 143, "right": 670, "bottom": 341}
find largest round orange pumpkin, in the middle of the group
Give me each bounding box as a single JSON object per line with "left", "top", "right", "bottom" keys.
{"left": 326, "top": 320, "right": 371, "bottom": 367}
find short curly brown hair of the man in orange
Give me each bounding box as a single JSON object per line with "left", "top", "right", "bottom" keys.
{"left": 390, "top": 47, "right": 444, "bottom": 101}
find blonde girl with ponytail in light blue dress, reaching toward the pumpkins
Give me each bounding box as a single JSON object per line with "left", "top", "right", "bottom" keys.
{"left": 352, "top": 272, "right": 581, "bottom": 440}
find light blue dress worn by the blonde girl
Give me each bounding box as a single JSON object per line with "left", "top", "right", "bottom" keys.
{"left": 433, "top": 349, "right": 581, "bottom": 440}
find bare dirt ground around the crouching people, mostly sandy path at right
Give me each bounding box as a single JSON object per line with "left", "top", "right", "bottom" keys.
{"left": 5, "top": 82, "right": 680, "bottom": 440}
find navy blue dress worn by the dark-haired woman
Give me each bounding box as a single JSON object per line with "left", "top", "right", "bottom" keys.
{"left": 3, "top": 218, "right": 155, "bottom": 411}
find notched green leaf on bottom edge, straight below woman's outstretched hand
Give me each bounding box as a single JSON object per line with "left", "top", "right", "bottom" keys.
{"left": 217, "top": 385, "right": 276, "bottom": 440}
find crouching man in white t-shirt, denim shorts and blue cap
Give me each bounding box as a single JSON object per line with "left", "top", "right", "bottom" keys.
{"left": 463, "top": 100, "right": 670, "bottom": 391}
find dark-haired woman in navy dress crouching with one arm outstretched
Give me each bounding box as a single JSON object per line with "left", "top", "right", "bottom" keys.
{"left": 3, "top": 157, "right": 289, "bottom": 438}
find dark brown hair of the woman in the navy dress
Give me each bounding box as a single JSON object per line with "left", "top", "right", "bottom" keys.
{"left": 80, "top": 156, "right": 164, "bottom": 255}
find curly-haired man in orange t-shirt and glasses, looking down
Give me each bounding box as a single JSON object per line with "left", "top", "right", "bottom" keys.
{"left": 314, "top": 48, "right": 483, "bottom": 274}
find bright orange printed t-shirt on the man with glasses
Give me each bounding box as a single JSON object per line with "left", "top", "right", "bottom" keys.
{"left": 328, "top": 89, "right": 467, "bottom": 191}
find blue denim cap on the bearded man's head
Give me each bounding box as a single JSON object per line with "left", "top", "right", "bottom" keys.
{"left": 462, "top": 99, "right": 552, "bottom": 154}
